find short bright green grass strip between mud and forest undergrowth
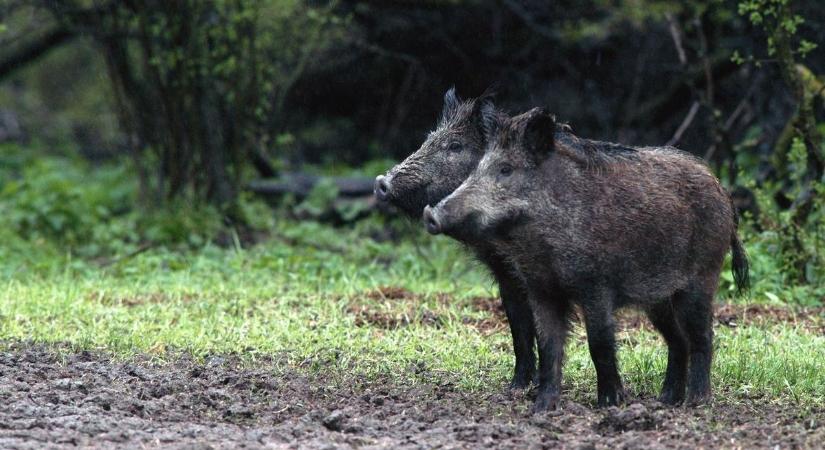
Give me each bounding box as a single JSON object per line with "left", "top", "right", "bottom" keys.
{"left": 0, "top": 221, "right": 825, "bottom": 406}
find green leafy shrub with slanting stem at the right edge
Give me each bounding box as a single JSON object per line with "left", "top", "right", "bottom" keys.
{"left": 733, "top": 0, "right": 825, "bottom": 288}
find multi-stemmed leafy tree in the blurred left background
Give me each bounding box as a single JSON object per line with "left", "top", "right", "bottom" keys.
{"left": 33, "top": 0, "right": 345, "bottom": 207}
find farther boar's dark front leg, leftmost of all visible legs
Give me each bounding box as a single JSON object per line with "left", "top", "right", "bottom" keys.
{"left": 497, "top": 277, "right": 536, "bottom": 389}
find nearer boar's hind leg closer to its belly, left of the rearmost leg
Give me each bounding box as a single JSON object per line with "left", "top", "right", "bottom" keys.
{"left": 647, "top": 299, "right": 690, "bottom": 405}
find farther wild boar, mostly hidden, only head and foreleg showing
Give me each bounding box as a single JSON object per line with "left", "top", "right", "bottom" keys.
{"left": 375, "top": 89, "right": 536, "bottom": 389}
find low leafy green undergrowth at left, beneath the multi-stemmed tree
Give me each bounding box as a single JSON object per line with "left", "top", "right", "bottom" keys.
{"left": 0, "top": 144, "right": 274, "bottom": 267}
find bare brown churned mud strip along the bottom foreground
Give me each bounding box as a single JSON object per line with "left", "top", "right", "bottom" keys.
{"left": 0, "top": 343, "right": 825, "bottom": 449}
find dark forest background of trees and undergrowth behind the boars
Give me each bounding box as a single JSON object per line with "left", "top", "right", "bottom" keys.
{"left": 0, "top": 0, "right": 825, "bottom": 298}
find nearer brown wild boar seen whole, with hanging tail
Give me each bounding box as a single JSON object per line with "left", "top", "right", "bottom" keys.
{"left": 424, "top": 108, "right": 748, "bottom": 411}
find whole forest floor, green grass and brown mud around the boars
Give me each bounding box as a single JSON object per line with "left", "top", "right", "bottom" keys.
{"left": 0, "top": 222, "right": 825, "bottom": 449}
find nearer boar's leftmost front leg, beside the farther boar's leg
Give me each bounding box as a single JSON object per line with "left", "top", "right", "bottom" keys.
{"left": 529, "top": 293, "right": 568, "bottom": 412}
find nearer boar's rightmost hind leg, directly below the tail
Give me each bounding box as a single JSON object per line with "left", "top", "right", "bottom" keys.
{"left": 673, "top": 286, "right": 713, "bottom": 405}
